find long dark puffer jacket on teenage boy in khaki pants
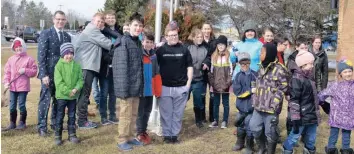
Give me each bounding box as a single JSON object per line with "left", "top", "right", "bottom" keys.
{"left": 112, "top": 33, "right": 144, "bottom": 99}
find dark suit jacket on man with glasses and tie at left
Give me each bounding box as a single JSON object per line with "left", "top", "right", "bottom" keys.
{"left": 37, "top": 26, "right": 71, "bottom": 85}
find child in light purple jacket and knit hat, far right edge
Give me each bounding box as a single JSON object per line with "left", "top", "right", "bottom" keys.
{"left": 318, "top": 60, "right": 354, "bottom": 154}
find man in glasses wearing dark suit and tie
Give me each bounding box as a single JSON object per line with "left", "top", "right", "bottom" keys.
{"left": 37, "top": 11, "right": 71, "bottom": 137}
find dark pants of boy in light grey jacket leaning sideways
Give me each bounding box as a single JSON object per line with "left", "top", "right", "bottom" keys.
{"left": 77, "top": 70, "right": 97, "bottom": 126}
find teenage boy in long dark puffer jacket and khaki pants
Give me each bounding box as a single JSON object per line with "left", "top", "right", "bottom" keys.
{"left": 112, "top": 13, "right": 144, "bottom": 151}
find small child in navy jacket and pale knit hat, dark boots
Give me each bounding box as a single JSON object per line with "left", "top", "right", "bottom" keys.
{"left": 232, "top": 52, "right": 258, "bottom": 153}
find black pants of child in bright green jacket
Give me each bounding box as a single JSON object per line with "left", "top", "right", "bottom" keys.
{"left": 55, "top": 99, "right": 76, "bottom": 137}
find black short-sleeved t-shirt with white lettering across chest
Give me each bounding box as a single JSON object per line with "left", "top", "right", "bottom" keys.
{"left": 156, "top": 43, "right": 193, "bottom": 87}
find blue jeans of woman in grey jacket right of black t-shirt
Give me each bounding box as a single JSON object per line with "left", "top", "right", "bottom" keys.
{"left": 188, "top": 81, "right": 206, "bottom": 110}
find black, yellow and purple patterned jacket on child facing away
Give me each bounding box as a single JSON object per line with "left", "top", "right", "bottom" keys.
{"left": 253, "top": 62, "right": 289, "bottom": 114}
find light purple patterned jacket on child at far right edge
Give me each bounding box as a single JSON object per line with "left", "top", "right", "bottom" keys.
{"left": 318, "top": 81, "right": 354, "bottom": 130}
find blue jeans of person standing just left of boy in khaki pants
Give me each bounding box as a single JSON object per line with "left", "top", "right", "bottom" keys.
{"left": 99, "top": 74, "right": 117, "bottom": 119}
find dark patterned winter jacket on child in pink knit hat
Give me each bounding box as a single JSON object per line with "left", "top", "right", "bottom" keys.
{"left": 289, "top": 70, "right": 320, "bottom": 126}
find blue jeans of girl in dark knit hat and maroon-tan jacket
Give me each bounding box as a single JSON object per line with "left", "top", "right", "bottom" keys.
{"left": 214, "top": 92, "right": 230, "bottom": 123}
